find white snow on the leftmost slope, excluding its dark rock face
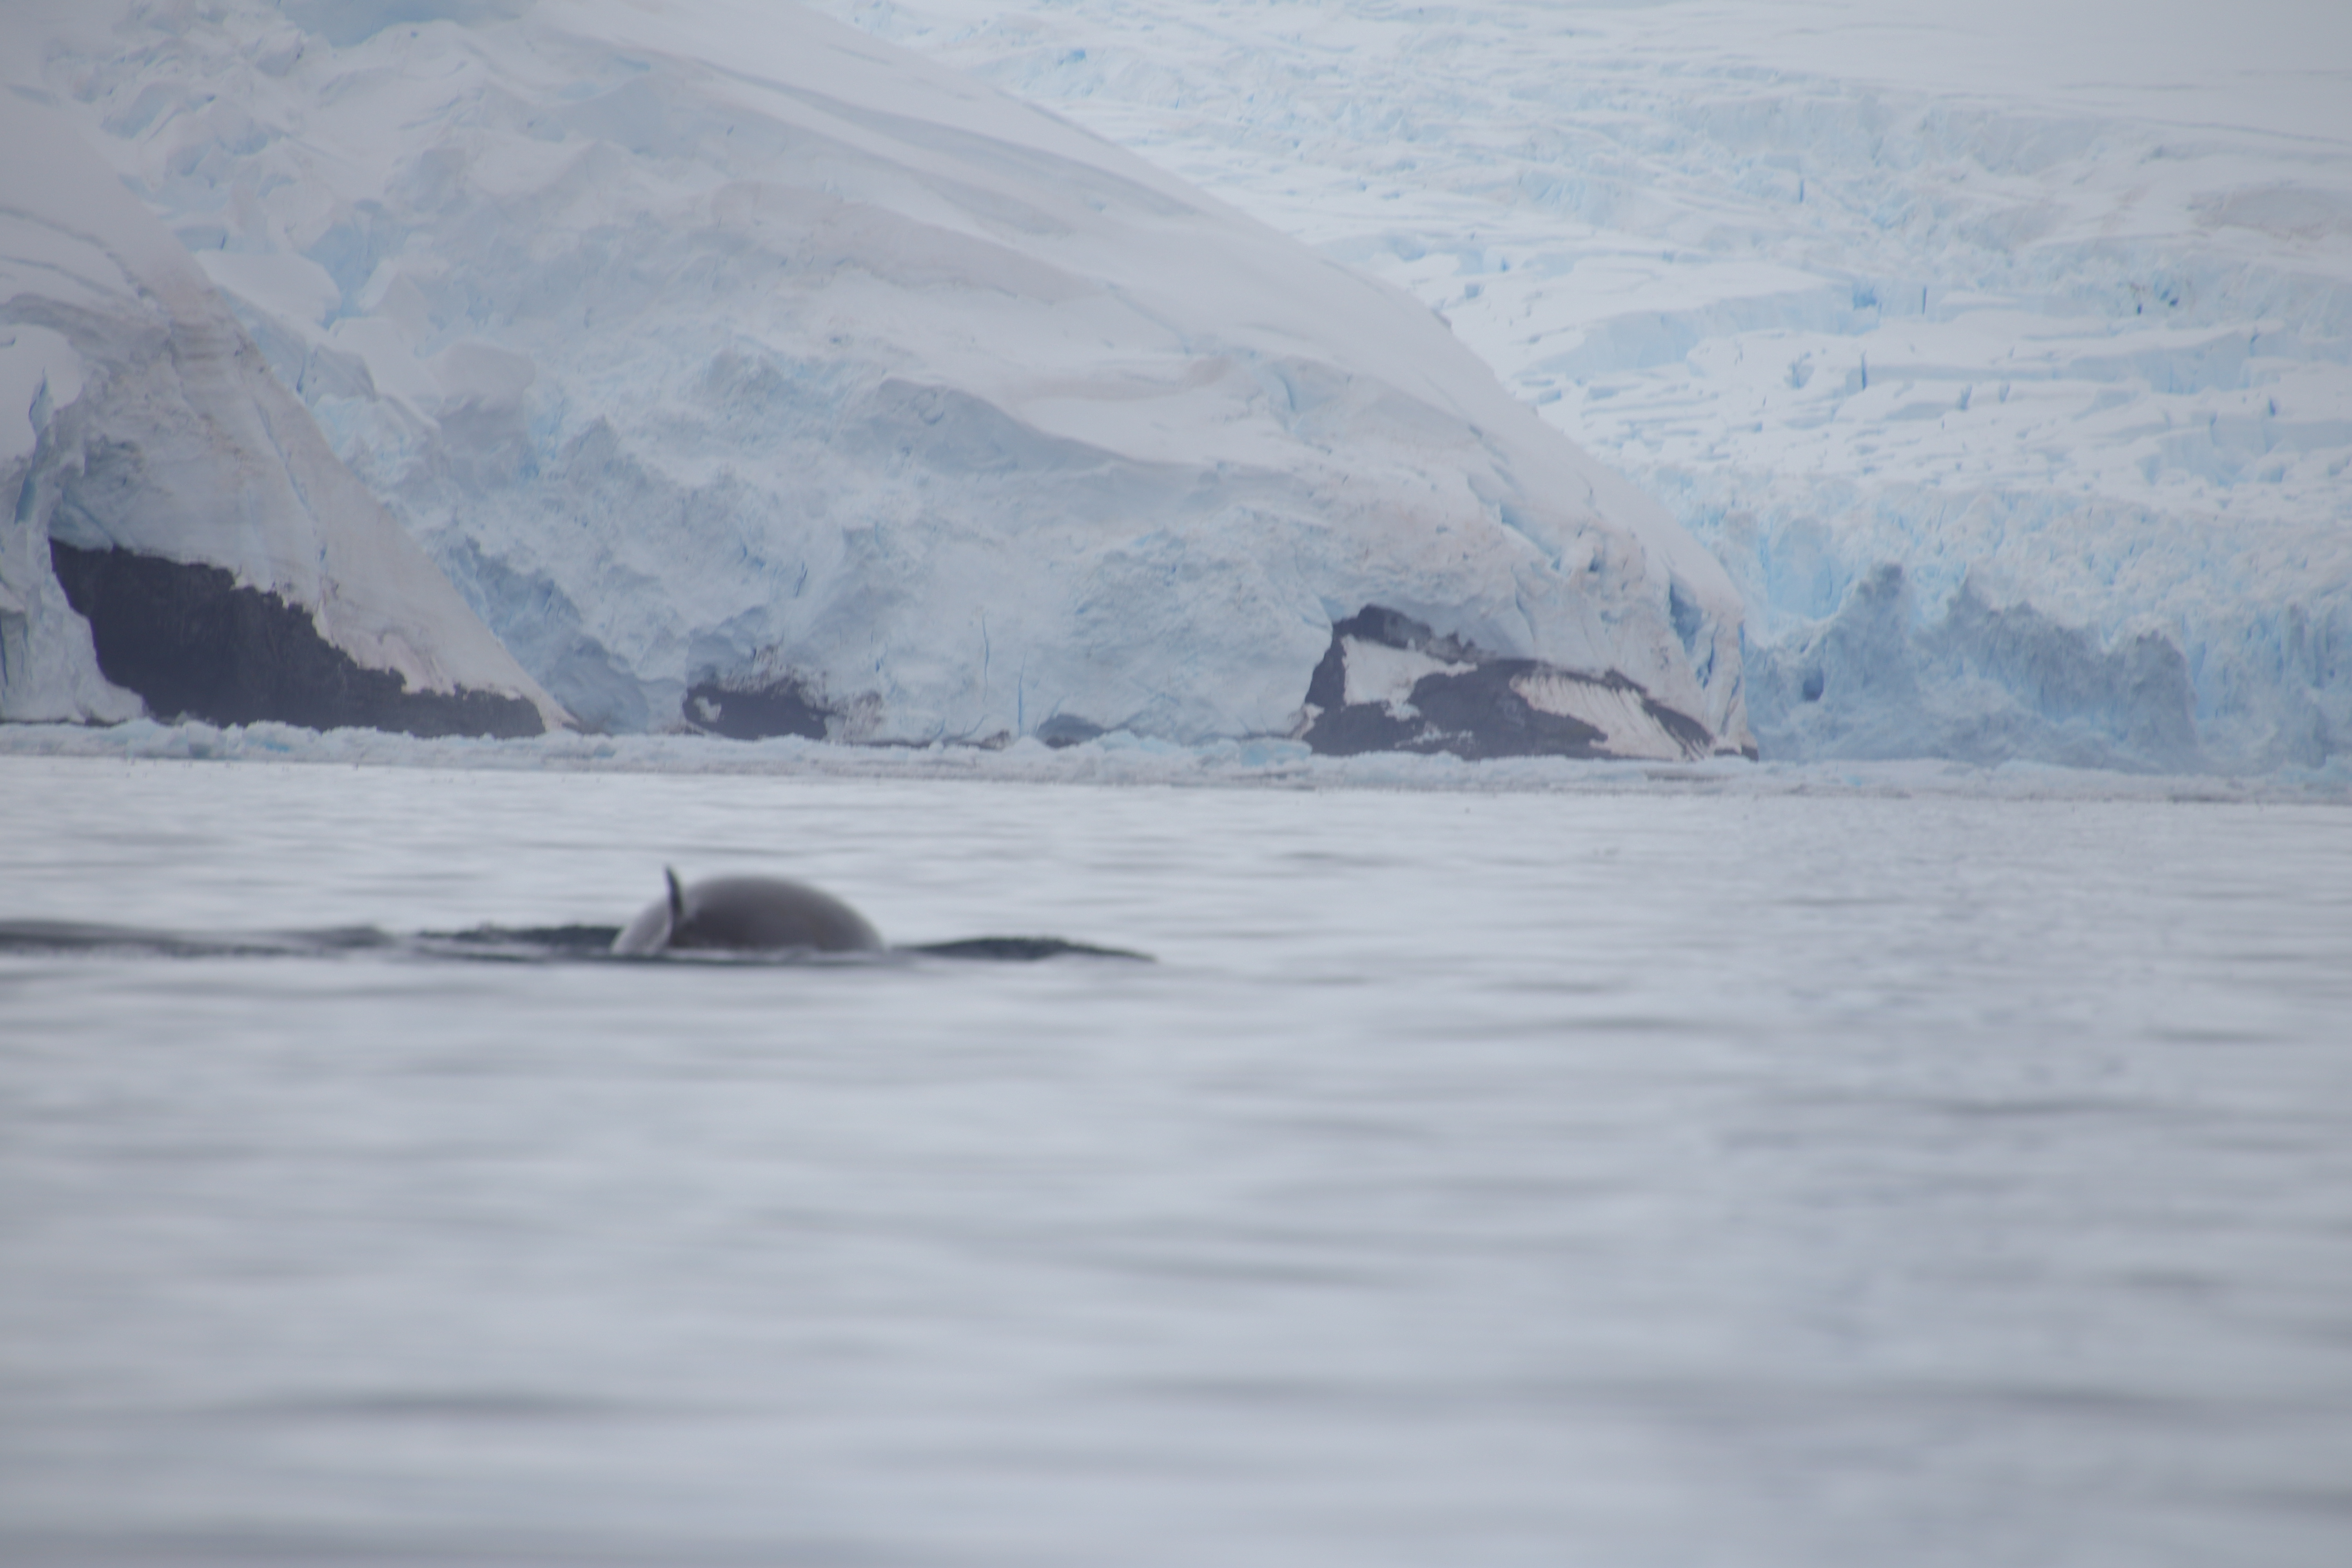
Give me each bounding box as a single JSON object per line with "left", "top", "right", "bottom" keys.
{"left": 0, "top": 83, "right": 562, "bottom": 724}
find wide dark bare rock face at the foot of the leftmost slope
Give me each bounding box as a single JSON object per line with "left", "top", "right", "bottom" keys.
{"left": 49, "top": 538, "right": 546, "bottom": 738}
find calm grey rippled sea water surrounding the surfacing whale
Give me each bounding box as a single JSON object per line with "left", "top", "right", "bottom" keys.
{"left": 0, "top": 757, "right": 2352, "bottom": 1568}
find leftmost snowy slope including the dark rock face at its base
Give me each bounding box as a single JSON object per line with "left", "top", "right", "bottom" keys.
{"left": 0, "top": 94, "right": 562, "bottom": 733}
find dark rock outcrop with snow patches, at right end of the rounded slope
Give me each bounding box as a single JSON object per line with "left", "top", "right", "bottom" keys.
{"left": 1301, "top": 604, "right": 1715, "bottom": 759}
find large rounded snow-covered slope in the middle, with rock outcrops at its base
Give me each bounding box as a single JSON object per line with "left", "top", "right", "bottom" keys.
{"left": 0, "top": 0, "right": 1748, "bottom": 755}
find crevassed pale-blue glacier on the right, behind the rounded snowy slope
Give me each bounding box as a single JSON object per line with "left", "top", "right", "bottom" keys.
{"left": 818, "top": 0, "right": 2352, "bottom": 769}
